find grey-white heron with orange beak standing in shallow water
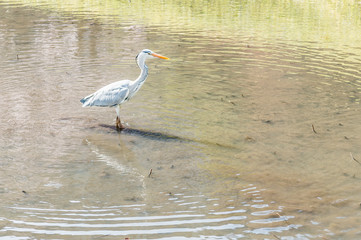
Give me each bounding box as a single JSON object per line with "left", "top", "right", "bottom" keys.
{"left": 80, "top": 49, "right": 169, "bottom": 130}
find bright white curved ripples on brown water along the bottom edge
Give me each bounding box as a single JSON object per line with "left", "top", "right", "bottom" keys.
{"left": 0, "top": 185, "right": 301, "bottom": 239}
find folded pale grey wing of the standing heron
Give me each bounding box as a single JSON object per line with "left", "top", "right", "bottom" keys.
{"left": 80, "top": 86, "right": 129, "bottom": 107}
